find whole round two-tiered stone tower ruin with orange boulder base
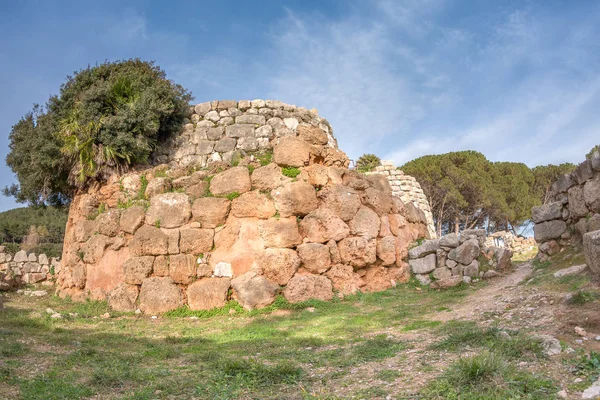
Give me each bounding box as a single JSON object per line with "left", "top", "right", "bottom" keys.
{"left": 57, "top": 100, "right": 429, "bottom": 314}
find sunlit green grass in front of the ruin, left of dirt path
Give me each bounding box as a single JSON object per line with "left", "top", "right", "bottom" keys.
{"left": 0, "top": 284, "right": 469, "bottom": 399}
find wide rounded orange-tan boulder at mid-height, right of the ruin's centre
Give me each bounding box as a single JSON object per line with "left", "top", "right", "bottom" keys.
{"left": 300, "top": 208, "right": 350, "bottom": 243}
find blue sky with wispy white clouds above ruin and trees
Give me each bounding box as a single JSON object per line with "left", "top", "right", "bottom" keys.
{"left": 0, "top": 0, "right": 600, "bottom": 211}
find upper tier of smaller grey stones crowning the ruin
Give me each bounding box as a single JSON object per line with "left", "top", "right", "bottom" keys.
{"left": 154, "top": 99, "right": 344, "bottom": 167}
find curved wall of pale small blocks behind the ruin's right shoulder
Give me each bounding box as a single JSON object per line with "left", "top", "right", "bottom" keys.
{"left": 367, "top": 160, "right": 437, "bottom": 239}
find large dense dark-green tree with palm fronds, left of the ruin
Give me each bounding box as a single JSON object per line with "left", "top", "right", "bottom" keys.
{"left": 4, "top": 59, "right": 192, "bottom": 204}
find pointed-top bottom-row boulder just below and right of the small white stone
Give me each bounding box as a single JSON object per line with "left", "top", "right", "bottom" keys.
{"left": 231, "top": 271, "right": 279, "bottom": 310}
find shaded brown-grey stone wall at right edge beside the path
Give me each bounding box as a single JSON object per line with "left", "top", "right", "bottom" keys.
{"left": 531, "top": 151, "right": 600, "bottom": 259}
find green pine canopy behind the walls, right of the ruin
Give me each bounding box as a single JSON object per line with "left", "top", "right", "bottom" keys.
{"left": 401, "top": 151, "right": 575, "bottom": 233}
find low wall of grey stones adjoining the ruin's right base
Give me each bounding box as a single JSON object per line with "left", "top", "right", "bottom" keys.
{"left": 408, "top": 229, "right": 512, "bottom": 288}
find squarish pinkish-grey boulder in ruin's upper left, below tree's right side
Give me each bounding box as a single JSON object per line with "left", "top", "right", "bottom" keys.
{"left": 146, "top": 193, "right": 192, "bottom": 229}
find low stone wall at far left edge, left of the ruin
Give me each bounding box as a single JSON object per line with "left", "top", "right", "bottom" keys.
{"left": 0, "top": 246, "right": 61, "bottom": 291}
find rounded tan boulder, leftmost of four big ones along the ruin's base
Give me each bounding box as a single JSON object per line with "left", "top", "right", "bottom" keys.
{"left": 140, "top": 277, "right": 183, "bottom": 314}
